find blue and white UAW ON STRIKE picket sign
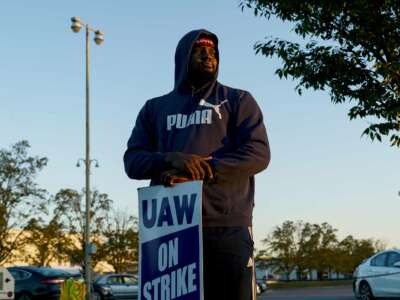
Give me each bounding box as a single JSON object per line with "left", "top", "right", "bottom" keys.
{"left": 138, "top": 181, "right": 203, "bottom": 300}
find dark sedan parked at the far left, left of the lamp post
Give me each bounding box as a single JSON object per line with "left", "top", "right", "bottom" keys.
{"left": 7, "top": 266, "right": 78, "bottom": 300}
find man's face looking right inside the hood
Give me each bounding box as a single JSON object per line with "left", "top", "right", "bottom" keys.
{"left": 190, "top": 45, "right": 218, "bottom": 79}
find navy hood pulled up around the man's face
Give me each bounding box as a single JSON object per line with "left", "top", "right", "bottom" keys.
{"left": 174, "top": 29, "right": 219, "bottom": 89}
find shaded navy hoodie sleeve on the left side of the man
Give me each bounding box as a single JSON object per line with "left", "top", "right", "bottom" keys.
{"left": 124, "top": 101, "right": 165, "bottom": 179}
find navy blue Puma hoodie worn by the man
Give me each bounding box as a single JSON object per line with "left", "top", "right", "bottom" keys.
{"left": 124, "top": 29, "right": 270, "bottom": 226}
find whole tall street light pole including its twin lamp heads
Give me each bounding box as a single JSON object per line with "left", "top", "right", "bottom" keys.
{"left": 71, "top": 17, "right": 104, "bottom": 300}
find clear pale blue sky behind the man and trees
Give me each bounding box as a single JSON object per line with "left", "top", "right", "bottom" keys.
{"left": 0, "top": 0, "right": 400, "bottom": 249}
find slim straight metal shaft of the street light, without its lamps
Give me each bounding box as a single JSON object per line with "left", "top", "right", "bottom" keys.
{"left": 85, "top": 25, "right": 92, "bottom": 300}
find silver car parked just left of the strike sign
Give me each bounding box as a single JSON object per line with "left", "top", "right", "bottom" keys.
{"left": 93, "top": 274, "right": 138, "bottom": 300}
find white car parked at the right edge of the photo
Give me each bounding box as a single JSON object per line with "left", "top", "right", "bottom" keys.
{"left": 353, "top": 250, "right": 400, "bottom": 300}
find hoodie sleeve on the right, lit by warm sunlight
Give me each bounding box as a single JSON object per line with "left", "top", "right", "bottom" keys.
{"left": 211, "top": 92, "right": 271, "bottom": 181}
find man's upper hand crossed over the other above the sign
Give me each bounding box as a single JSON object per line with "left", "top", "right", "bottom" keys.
{"left": 165, "top": 152, "right": 214, "bottom": 180}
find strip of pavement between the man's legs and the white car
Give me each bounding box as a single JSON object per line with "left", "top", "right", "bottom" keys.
{"left": 257, "top": 285, "right": 355, "bottom": 300}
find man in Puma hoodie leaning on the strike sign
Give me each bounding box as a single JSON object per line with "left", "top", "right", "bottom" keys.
{"left": 124, "top": 29, "right": 270, "bottom": 300}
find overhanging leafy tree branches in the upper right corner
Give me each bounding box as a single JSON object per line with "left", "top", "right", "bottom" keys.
{"left": 240, "top": 0, "right": 400, "bottom": 147}
